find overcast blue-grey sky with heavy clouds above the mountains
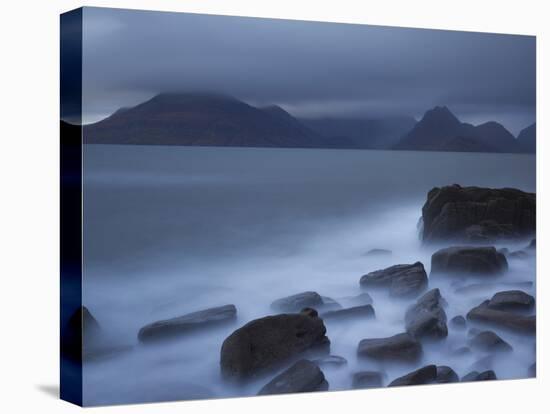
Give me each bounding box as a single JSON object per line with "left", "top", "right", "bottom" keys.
{"left": 83, "top": 8, "right": 536, "bottom": 134}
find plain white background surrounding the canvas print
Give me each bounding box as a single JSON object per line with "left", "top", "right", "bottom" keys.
{"left": 0, "top": 0, "right": 550, "bottom": 414}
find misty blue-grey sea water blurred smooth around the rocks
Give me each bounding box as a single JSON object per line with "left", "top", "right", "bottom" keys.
{"left": 83, "top": 145, "right": 535, "bottom": 405}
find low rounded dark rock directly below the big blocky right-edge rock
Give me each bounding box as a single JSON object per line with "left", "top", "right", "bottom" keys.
{"left": 430, "top": 246, "right": 508, "bottom": 277}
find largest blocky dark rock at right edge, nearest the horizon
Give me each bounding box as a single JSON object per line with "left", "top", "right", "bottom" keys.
{"left": 422, "top": 184, "right": 536, "bottom": 242}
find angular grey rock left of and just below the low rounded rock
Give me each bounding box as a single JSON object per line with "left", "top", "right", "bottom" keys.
{"left": 359, "top": 262, "right": 428, "bottom": 297}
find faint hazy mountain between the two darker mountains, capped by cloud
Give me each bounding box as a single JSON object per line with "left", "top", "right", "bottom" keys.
{"left": 300, "top": 116, "right": 416, "bottom": 149}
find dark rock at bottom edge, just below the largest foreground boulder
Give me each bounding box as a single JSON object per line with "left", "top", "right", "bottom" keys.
{"left": 258, "top": 359, "right": 328, "bottom": 395}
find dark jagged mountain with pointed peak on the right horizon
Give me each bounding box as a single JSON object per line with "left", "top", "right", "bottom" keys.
{"left": 394, "top": 106, "right": 520, "bottom": 153}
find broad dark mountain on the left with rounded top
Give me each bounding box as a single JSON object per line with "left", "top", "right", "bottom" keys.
{"left": 84, "top": 93, "right": 356, "bottom": 148}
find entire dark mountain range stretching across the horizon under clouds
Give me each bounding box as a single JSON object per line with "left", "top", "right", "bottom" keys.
{"left": 84, "top": 93, "right": 536, "bottom": 153}
